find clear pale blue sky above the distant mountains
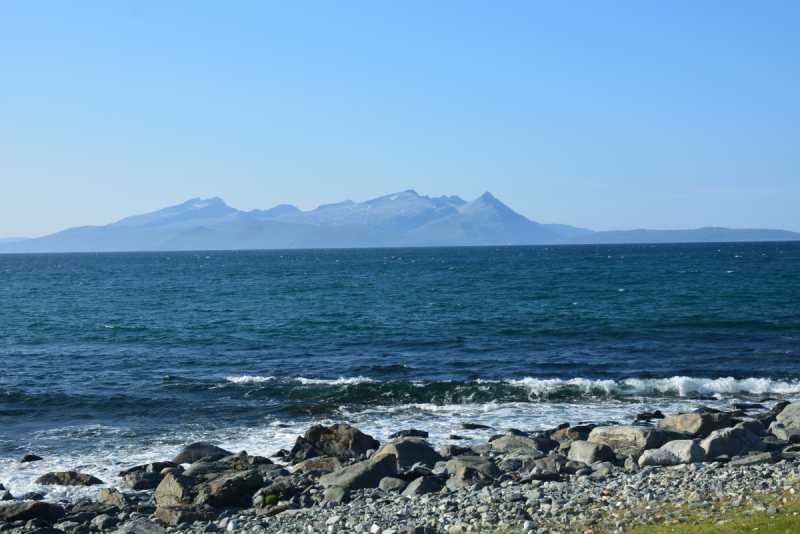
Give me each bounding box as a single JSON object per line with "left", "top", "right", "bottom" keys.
{"left": 0, "top": 0, "right": 800, "bottom": 237}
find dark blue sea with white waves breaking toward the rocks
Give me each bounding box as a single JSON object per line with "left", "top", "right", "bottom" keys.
{"left": 0, "top": 242, "right": 800, "bottom": 500}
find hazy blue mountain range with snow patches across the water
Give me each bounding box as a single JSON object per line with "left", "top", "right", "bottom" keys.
{"left": 0, "top": 190, "right": 800, "bottom": 253}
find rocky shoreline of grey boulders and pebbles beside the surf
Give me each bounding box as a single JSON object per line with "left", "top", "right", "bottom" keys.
{"left": 0, "top": 402, "right": 800, "bottom": 534}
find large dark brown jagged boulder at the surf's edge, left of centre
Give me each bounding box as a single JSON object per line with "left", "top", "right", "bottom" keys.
{"left": 287, "top": 424, "right": 380, "bottom": 463}
